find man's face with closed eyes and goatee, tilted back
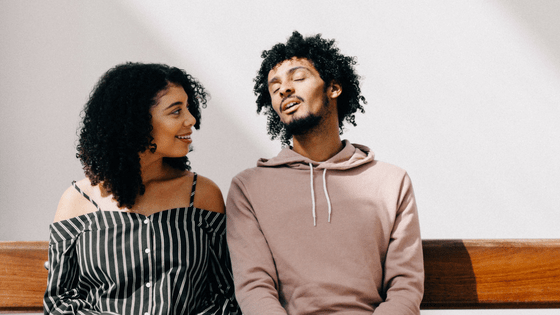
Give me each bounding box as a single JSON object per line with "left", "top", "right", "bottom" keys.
{"left": 268, "top": 57, "right": 329, "bottom": 135}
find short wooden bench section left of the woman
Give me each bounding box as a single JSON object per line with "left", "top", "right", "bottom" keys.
{"left": 0, "top": 242, "right": 48, "bottom": 313}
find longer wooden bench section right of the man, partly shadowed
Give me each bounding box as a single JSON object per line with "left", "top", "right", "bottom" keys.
{"left": 422, "top": 240, "right": 560, "bottom": 309}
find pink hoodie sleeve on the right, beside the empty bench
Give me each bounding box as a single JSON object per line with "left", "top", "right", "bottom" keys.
{"left": 373, "top": 175, "right": 424, "bottom": 315}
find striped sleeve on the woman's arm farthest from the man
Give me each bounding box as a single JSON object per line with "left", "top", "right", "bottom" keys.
{"left": 43, "top": 228, "right": 109, "bottom": 314}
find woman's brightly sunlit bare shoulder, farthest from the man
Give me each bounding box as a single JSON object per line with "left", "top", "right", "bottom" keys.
{"left": 54, "top": 178, "right": 97, "bottom": 222}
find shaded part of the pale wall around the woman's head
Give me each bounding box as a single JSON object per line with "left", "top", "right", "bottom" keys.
{"left": 0, "top": 1, "right": 265, "bottom": 241}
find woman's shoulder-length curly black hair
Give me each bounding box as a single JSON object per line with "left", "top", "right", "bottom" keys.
{"left": 76, "top": 63, "right": 207, "bottom": 208}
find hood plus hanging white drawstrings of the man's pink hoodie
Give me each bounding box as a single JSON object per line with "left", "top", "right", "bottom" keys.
{"left": 257, "top": 140, "right": 374, "bottom": 226}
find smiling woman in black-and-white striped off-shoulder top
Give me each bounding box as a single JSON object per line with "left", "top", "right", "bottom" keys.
{"left": 44, "top": 63, "right": 240, "bottom": 315}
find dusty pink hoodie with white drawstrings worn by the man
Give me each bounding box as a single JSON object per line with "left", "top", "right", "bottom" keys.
{"left": 227, "top": 141, "right": 424, "bottom": 315}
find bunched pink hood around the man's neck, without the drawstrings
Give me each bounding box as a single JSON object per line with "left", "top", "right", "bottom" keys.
{"left": 257, "top": 140, "right": 375, "bottom": 170}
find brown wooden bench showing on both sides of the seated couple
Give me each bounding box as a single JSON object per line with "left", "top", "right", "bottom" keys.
{"left": 0, "top": 240, "right": 560, "bottom": 313}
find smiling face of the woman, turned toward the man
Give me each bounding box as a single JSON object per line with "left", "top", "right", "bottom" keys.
{"left": 150, "top": 83, "right": 196, "bottom": 157}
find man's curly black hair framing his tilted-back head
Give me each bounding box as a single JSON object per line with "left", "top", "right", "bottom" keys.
{"left": 253, "top": 31, "right": 367, "bottom": 145}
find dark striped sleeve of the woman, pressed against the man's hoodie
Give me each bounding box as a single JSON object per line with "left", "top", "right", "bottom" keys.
{"left": 202, "top": 215, "right": 241, "bottom": 315}
